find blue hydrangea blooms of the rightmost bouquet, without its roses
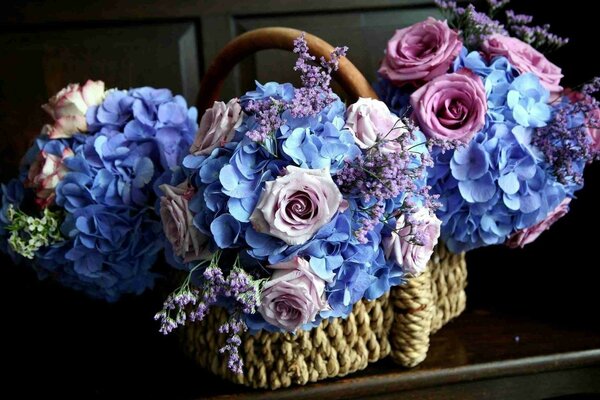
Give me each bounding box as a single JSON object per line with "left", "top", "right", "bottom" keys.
{"left": 429, "top": 49, "right": 575, "bottom": 252}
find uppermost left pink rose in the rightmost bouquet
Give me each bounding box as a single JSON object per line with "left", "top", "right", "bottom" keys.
{"left": 379, "top": 17, "right": 462, "bottom": 85}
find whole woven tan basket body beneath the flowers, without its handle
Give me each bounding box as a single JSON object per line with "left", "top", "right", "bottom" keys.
{"left": 182, "top": 242, "right": 466, "bottom": 389}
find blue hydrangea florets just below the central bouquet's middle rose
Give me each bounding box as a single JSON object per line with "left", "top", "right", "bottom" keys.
{"left": 245, "top": 210, "right": 404, "bottom": 331}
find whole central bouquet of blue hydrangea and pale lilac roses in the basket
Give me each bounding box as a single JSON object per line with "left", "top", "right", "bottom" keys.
{"left": 156, "top": 32, "right": 450, "bottom": 378}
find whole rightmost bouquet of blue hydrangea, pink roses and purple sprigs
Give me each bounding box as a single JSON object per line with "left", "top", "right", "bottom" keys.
{"left": 376, "top": 0, "right": 600, "bottom": 252}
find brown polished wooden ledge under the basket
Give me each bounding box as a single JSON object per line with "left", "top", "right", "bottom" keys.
{"left": 198, "top": 310, "right": 600, "bottom": 400}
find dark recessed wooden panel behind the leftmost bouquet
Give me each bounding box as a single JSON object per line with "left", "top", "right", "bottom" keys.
{"left": 0, "top": 23, "right": 199, "bottom": 180}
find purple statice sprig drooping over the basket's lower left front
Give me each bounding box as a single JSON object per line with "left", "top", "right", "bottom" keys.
{"left": 154, "top": 251, "right": 267, "bottom": 374}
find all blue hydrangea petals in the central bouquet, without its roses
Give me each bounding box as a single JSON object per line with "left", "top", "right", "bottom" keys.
{"left": 168, "top": 82, "right": 403, "bottom": 331}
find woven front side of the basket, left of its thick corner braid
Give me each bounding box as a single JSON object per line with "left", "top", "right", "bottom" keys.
{"left": 184, "top": 295, "right": 393, "bottom": 389}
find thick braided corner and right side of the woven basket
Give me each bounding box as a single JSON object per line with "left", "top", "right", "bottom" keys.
{"left": 390, "top": 245, "right": 467, "bottom": 367}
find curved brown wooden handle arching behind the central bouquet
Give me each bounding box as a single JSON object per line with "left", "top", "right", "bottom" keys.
{"left": 196, "top": 27, "right": 377, "bottom": 113}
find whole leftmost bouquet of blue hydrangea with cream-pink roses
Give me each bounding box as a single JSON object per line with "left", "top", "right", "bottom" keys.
{"left": 0, "top": 81, "right": 197, "bottom": 301}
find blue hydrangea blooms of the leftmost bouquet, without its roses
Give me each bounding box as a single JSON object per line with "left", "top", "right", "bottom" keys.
{"left": 0, "top": 87, "right": 197, "bottom": 301}
